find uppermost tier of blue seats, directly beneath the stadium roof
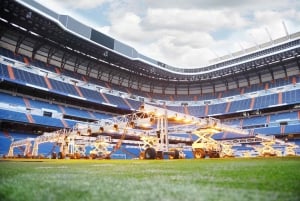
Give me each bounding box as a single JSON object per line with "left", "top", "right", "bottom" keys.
{"left": 0, "top": 48, "right": 300, "bottom": 103}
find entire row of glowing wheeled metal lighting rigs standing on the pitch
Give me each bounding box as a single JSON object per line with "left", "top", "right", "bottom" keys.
{"left": 8, "top": 104, "right": 295, "bottom": 159}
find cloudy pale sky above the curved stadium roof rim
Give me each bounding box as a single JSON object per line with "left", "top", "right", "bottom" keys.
{"left": 36, "top": 0, "right": 300, "bottom": 68}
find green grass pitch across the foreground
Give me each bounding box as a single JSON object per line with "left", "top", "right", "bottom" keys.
{"left": 0, "top": 157, "right": 300, "bottom": 201}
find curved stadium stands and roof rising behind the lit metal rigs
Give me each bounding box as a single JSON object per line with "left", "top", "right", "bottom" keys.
{"left": 0, "top": 0, "right": 300, "bottom": 155}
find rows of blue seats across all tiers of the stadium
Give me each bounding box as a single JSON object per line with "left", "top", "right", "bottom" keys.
{"left": 0, "top": 37, "right": 300, "bottom": 158}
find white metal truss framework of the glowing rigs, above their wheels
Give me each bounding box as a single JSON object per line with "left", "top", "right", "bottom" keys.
{"left": 8, "top": 104, "right": 295, "bottom": 157}
